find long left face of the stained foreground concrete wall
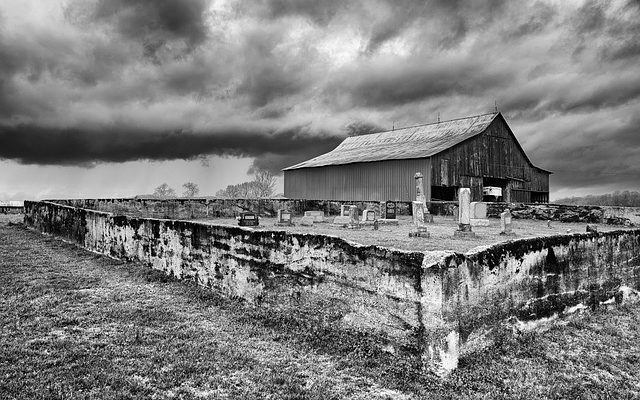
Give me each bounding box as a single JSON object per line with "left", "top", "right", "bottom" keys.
{"left": 25, "top": 202, "right": 430, "bottom": 344}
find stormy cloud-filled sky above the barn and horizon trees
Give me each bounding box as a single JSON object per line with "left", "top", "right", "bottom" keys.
{"left": 0, "top": 0, "right": 640, "bottom": 200}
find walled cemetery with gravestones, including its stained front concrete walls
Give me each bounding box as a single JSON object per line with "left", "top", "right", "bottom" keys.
{"left": 20, "top": 181, "right": 640, "bottom": 374}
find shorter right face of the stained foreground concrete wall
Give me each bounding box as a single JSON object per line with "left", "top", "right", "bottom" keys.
{"left": 439, "top": 234, "right": 640, "bottom": 340}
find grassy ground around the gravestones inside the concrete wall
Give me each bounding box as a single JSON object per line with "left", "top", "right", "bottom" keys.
{"left": 194, "top": 215, "right": 630, "bottom": 253}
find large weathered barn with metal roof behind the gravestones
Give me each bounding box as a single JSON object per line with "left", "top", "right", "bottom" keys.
{"left": 283, "top": 113, "right": 551, "bottom": 202}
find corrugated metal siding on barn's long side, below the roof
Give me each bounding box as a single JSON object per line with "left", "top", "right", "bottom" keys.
{"left": 284, "top": 158, "right": 431, "bottom": 201}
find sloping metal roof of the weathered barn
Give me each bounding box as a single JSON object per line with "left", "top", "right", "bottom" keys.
{"left": 284, "top": 113, "right": 498, "bottom": 171}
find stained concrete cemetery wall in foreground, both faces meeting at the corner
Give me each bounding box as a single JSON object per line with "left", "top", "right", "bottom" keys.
{"left": 25, "top": 202, "right": 640, "bottom": 370}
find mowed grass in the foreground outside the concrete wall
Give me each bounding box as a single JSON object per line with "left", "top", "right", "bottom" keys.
{"left": 0, "top": 216, "right": 640, "bottom": 400}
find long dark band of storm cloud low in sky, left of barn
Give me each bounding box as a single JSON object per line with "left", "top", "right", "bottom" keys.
{"left": 0, "top": 125, "right": 342, "bottom": 168}
